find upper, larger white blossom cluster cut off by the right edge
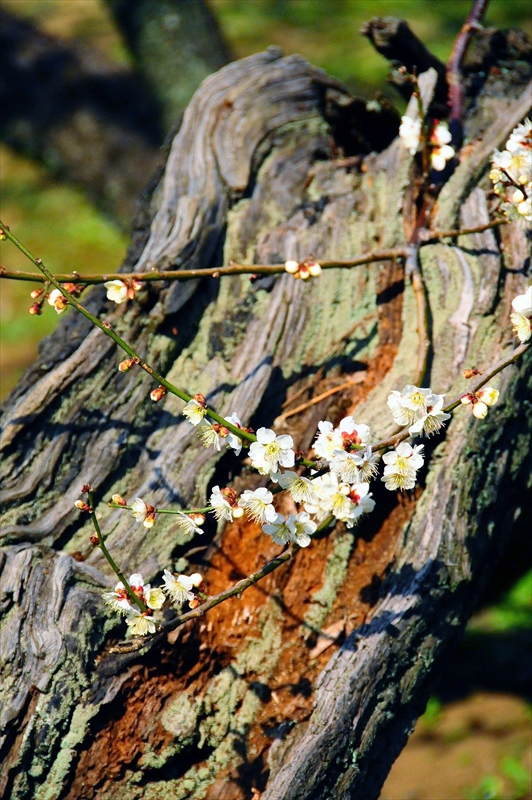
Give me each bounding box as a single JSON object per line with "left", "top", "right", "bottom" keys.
{"left": 489, "top": 119, "right": 532, "bottom": 228}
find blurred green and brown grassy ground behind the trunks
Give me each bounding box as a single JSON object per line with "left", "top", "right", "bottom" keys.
{"left": 0, "top": 0, "right": 532, "bottom": 800}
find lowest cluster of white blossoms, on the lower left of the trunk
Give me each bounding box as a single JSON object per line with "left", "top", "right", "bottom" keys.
{"left": 103, "top": 569, "right": 203, "bottom": 636}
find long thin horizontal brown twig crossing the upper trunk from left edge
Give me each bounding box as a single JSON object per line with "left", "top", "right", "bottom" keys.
{"left": 0, "top": 250, "right": 406, "bottom": 286}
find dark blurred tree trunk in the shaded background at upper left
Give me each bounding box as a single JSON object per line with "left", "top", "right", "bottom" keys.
{"left": 0, "top": 0, "right": 229, "bottom": 228}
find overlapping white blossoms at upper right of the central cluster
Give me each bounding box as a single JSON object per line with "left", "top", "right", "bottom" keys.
{"left": 388, "top": 384, "right": 451, "bottom": 435}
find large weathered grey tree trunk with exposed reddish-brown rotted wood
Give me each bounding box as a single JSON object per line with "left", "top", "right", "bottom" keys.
{"left": 0, "top": 21, "right": 532, "bottom": 800}
